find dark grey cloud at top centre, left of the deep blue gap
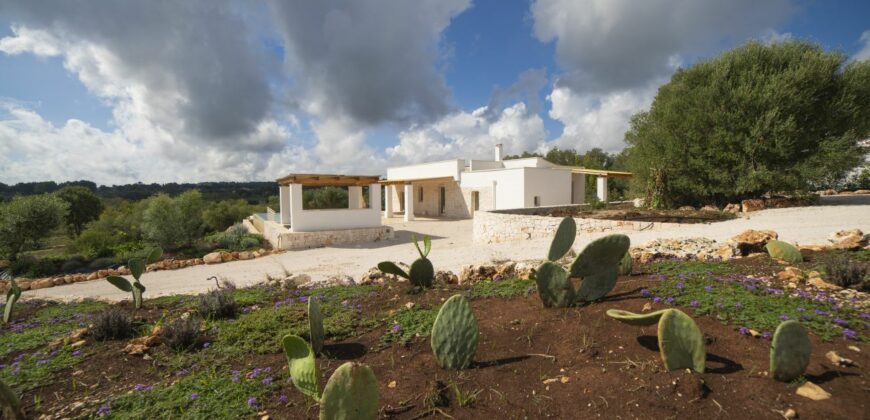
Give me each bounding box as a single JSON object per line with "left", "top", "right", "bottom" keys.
{"left": 272, "top": 0, "right": 470, "bottom": 126}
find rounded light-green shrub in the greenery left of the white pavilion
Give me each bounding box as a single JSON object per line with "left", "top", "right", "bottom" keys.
{"left": 142, "top": 190, "right": 203, "bottom": 249}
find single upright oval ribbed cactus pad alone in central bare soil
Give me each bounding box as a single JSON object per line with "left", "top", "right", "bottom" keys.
{"left": 431, "top": 295, "right": 478, "bottom": 369}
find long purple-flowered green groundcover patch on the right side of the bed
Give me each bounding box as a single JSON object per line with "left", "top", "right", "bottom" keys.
{"left": 641, "top": 273, "right": 867, "bottom": 341}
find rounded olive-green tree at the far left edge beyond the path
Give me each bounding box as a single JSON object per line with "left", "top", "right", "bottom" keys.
{"left": 0, "top": 194, "right": 69, "bottom": 260}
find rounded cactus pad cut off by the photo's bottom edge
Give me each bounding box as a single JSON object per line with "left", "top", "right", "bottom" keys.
{"left": 320, "top": 362, "right": 380, "bottom": 420}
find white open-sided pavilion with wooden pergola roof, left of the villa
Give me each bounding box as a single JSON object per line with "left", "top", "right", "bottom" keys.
{"left": 277, "top": 174, "right": 381, "bottom": 232}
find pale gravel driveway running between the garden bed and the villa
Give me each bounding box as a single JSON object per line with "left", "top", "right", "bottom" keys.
{"left": 24, "top": 196, "right": 870, "bottom": 300}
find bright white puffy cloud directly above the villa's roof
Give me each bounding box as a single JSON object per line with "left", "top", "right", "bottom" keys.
{"left": 386, "top": 102, "right": 546, "bottom": 164}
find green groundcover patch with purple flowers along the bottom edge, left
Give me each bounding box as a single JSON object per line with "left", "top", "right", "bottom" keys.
{"left": 103, "top": 371, "right": 280, "bottom": 419}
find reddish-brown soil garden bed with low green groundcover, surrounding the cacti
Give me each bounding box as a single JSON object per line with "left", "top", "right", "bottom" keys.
{"left": 0, "top": 251, "right": 870, "bottom": 419}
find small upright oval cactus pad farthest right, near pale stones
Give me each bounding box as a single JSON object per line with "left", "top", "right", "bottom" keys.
{"left": 770, "top": 320, "right": 812, "bottom": 382}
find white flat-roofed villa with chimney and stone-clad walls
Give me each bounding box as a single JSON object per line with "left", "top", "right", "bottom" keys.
{"left": 381, "top": 144, "right": 631, "bottom": 221}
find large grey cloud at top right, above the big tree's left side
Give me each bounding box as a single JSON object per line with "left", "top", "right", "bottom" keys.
{"left": 531, "top": 0, "right": 795, "bottom": 93}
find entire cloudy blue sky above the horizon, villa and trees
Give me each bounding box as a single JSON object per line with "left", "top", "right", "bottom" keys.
{"left": 0, "top": 0, "right": 870, "bottom": 185}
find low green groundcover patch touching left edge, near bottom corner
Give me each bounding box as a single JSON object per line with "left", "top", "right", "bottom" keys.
{"left": 0, "top": 346, "right": 82, "bottom": 393}
